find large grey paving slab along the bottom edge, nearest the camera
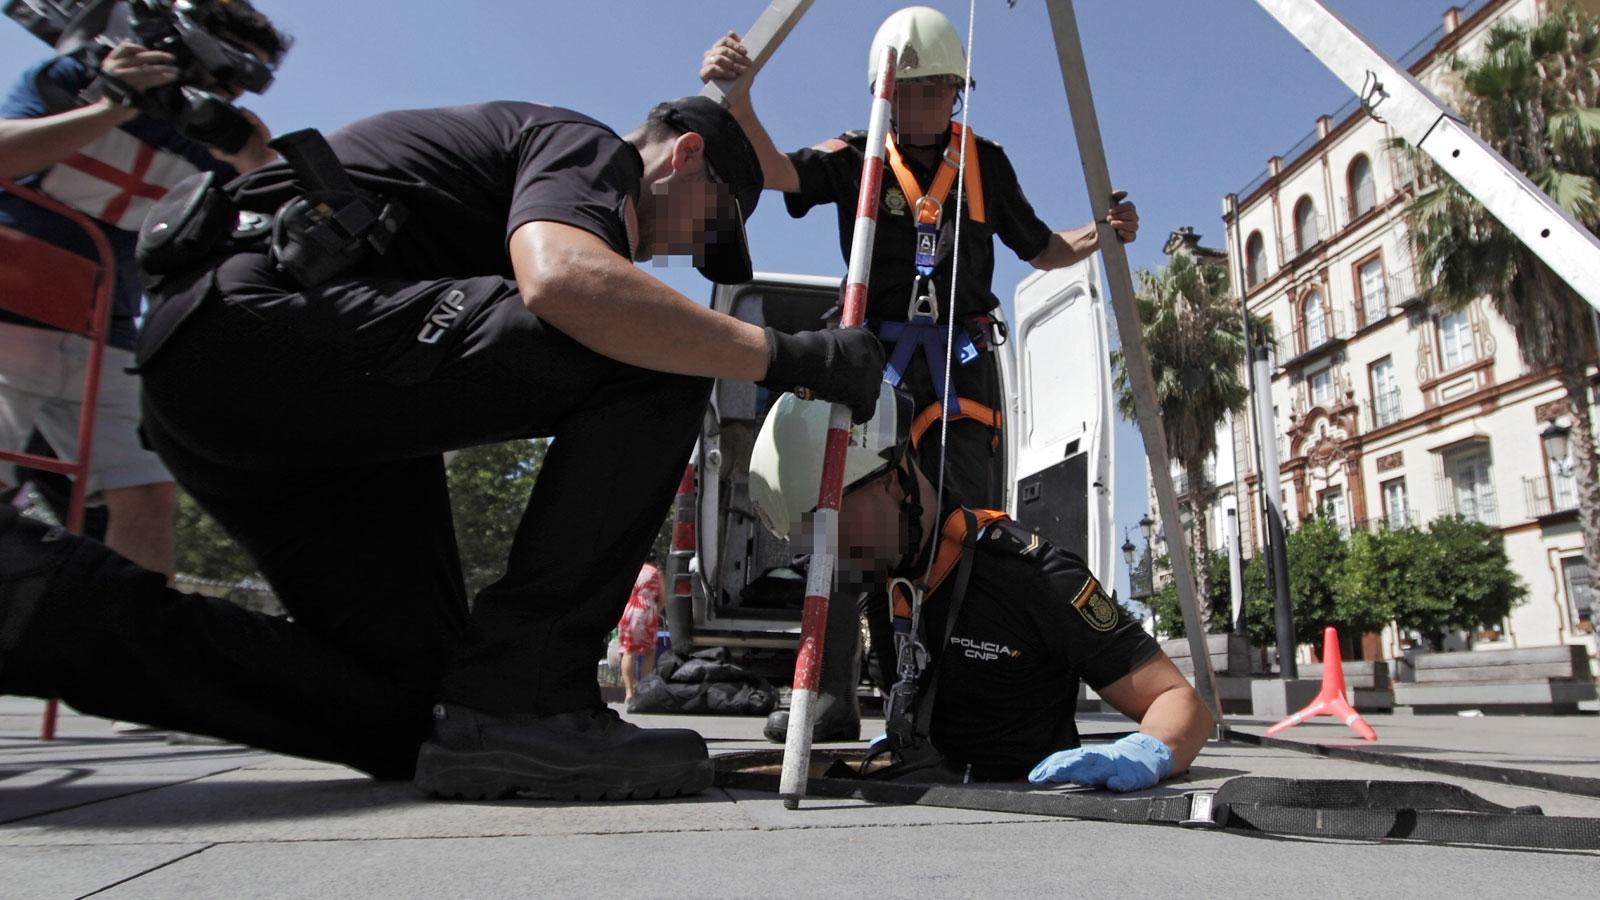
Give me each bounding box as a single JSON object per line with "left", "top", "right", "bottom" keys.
{"left": 90, "top": 822, "right": 1594, "bottom": 900}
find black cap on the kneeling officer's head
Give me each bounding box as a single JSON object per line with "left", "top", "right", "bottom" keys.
{"left": 650, "top": 96, "right": 762, "bottom": 285}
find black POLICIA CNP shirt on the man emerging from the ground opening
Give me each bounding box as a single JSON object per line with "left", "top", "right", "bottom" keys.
{"left": 923, "top": 519, "right": 1160, "bottom": 781}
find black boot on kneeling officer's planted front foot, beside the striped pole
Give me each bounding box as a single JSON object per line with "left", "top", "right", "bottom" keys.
{"left": 416, "top": 705, "right": 712, "bottom": 801}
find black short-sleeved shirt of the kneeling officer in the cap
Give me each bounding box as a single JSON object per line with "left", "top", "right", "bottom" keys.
{"left": 227, "top": 101, "right": 645, "bottom": 279}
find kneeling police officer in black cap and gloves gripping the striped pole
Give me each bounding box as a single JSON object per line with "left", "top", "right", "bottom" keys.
{"left": 0, "top": 98, "right": 883, "bottom": 799}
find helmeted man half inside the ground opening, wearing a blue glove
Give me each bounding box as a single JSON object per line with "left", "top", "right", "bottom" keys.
{"left": 750, "top": 383, "right": 1211, "bottom": 791}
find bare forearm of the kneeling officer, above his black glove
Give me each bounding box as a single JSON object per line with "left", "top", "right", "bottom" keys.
{"left": 510, "top": 223, "right": 768, "bottom": 381}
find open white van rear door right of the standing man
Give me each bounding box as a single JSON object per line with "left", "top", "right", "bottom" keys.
{"left": 1000, "top": 256, "right": 1115, "bottom": 578}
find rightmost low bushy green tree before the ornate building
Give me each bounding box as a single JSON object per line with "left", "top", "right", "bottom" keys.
{"left": 1395, "top": 516, "right": 1528, "bottom": 649}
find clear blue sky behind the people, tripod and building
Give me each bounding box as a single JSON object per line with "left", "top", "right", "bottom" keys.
{"left": 0, "top": 0, "right": 1450, "bottom": 596}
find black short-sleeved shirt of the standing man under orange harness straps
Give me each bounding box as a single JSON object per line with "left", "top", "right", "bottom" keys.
{"left": 784, "top": 131, "right": 1050, "bottom": 322}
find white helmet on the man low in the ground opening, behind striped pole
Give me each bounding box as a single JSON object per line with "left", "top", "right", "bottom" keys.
{"left": 750, "top": 381, "right": 912, "bottom": 538}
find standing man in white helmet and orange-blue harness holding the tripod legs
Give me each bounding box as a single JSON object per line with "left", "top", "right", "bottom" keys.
{"left": 699, "top": 6, "right": 1139, "bottom": 743}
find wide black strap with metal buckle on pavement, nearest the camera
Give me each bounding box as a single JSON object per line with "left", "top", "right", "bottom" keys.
{"left": 717, "top": 751, "right": 1600, "bottom": 852}
